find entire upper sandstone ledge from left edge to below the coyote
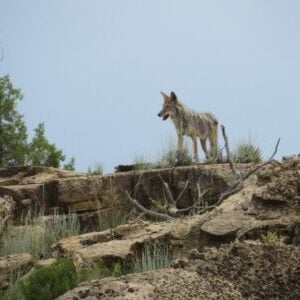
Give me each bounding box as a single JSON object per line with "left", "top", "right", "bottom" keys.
{"left": 0, "top": 164, "right": 231, "bottom": 219}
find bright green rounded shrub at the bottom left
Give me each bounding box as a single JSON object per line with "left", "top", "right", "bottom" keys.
{"left": 21, "top": 259, "right": 78, "bottom": 300}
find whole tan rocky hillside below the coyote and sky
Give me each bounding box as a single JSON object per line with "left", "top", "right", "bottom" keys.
{"left": 0, "top": 156, "right": 300, "bottom": 299}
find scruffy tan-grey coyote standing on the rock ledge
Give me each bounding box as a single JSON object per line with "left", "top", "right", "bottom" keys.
{"left": 158, "top": 92, "right": 218, "bottom": 162}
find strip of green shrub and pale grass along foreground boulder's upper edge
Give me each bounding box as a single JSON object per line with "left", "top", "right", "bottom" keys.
{"left": 0, "top": 242, "right": 172, "bottom": 300}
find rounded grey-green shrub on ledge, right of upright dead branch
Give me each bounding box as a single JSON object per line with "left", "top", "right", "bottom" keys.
{"left": 232, "top": 142, "right": 262, "bottom": 163}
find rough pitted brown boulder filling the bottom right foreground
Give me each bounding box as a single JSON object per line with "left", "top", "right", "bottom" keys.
{"left": 58, "top": 242, "right": 300, "bottom": 300}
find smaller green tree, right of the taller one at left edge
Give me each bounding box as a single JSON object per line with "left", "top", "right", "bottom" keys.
{"left": 28, "top": 123, "right": 65, "bottom": 168}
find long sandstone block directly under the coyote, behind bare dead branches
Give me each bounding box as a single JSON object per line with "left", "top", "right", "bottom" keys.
{"left": 57, "top": 164, "right": 231, "bottom": 211}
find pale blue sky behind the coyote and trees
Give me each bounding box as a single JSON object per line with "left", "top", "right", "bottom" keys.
{"left": 0, "top": 0, "right": 300, "bottom": 171}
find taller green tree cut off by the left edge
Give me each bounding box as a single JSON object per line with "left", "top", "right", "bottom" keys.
{"left": 0, "top": 75, "right": 28, "bottom": 167}
